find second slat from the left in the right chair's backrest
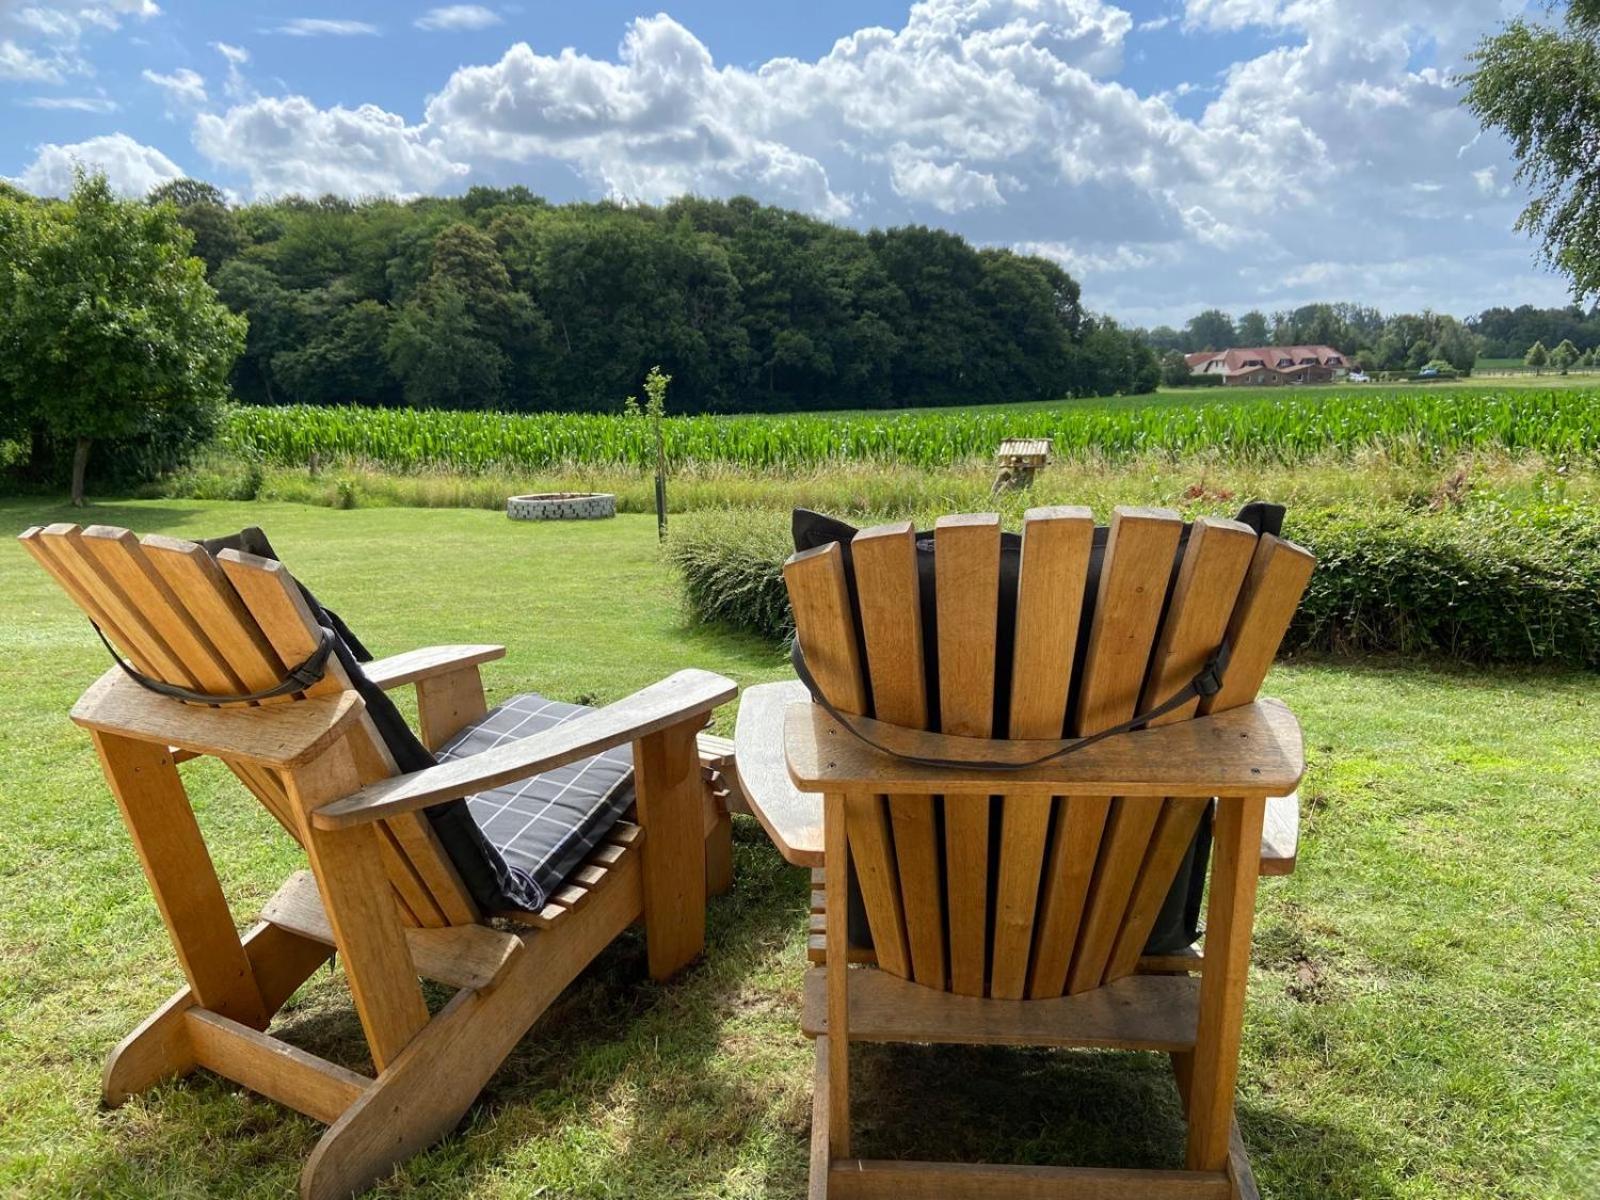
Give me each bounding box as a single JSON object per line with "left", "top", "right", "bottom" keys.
{"left": 846, "top": 522, "right": 946, "bottom": 987}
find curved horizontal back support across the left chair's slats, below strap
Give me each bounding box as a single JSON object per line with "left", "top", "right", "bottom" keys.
{"left": 72, "top": 667, "right": 366, "bottom": 766}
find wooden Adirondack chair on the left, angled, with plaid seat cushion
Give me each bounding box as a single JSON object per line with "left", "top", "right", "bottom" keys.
{"left": 22, "top": 525, "right": 734, "bottom": 1198}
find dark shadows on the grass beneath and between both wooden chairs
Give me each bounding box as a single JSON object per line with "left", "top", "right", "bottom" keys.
{"left": 34, "top": 818, "right": 1390, "bottom": 1200}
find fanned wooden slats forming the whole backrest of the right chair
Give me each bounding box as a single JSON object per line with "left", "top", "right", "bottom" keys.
{"left": 784, "top": 509, "right": 1312, "bottom": 1000}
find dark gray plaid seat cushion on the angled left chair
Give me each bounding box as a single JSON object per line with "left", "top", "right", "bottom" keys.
{"left": 438, "top": 691, "right": 634, "bottom": 912}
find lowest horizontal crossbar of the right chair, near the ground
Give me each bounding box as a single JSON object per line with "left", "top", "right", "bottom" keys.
{"left": 827, "top": 1158, "right": 1229, "bottom": 1200}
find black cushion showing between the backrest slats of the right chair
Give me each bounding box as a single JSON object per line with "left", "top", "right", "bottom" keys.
{"left": 792, "top": 501, "right": 1283, "bottom": 954}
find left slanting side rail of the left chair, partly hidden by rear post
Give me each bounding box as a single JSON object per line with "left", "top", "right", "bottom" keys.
{"left": 101, "top": 922, "right": 333, "bottom": 1107}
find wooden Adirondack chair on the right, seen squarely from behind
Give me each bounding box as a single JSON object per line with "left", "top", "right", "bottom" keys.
{"left": 761, "top": 509, "right": 1314, "bottom": 1200}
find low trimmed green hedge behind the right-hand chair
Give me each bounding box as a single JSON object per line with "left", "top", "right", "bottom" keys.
{"left": 667, "top": 504, "right": 1600, "bottom": 667}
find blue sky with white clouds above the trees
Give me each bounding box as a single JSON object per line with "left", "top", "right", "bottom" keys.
{"left": 0, "top": 0, "right": 1566, "bottom": 323}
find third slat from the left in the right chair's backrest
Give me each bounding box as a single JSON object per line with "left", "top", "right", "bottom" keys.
{"left": 934, "top": 512, "right": 1000, "bottom": 995}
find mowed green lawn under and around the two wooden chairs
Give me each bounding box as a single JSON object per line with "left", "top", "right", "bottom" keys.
{"left": 0, "top": 501, "right": 1600, "bottom": 1200}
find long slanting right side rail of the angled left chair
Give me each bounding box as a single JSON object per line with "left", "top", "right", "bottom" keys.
{"left": 301, "top": 856, "right": 642, "bottom": 1200}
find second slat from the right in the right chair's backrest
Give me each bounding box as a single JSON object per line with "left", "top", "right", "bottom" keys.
{"left": 1067, "top": 517, "right": 1256, "bottom": 992}
